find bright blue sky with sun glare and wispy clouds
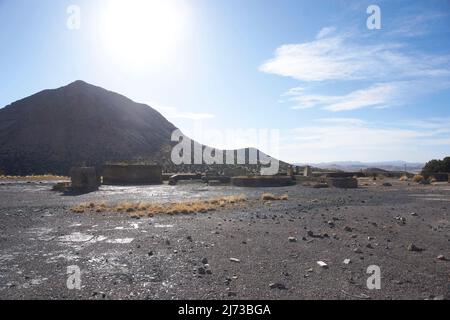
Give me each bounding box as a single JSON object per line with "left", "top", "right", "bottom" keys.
{"left": 0, "top": 0, "right": 450, "bottom": 163}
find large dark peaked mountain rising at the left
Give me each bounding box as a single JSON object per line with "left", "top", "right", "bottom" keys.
{"left": 0, "top": 81, "right": 286, "bottom": 175}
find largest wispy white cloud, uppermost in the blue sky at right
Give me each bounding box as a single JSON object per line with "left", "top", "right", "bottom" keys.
{"left": 260, "top": 28, "right": 450, "bottom": 81}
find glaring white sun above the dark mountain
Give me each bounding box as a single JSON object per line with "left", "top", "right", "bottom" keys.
{"left": 101, "top": 0, "right": 185, "bottom": 68}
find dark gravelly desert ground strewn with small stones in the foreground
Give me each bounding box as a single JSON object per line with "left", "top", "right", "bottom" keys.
{"left": 0, "top": 180, "right": 450, "bottom": 300}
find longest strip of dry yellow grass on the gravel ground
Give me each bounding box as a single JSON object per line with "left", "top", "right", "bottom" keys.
{"left": 71, "top": 195, "right": 248, "bottom": 218}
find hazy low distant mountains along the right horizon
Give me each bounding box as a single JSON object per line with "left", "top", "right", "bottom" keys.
{"left": 298, "top": 160, "right": 425, "bottom": 173}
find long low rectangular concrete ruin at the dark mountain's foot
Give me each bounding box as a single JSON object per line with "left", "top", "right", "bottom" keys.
{"left": 103, "top": 165, "right": 162, "bottom": 185}
